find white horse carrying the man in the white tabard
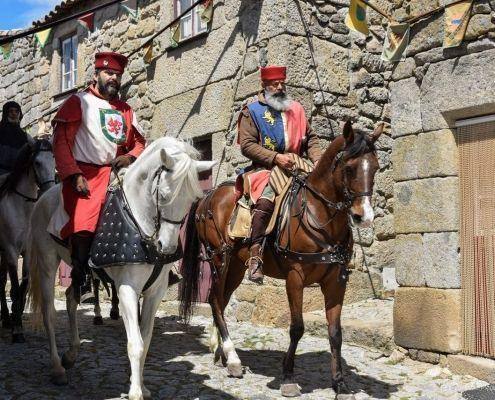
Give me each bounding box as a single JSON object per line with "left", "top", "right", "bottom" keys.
{"left": 28, "top": 137, "right": 216, "bottom": 400}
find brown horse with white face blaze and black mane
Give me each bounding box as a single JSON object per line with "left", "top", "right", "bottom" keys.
{"left": 181, "top": 122, "right": 383, "bottom": 398}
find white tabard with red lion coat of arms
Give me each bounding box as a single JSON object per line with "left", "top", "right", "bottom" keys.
{"left": 73, "top": 92, "right": 141, "bottom": 165}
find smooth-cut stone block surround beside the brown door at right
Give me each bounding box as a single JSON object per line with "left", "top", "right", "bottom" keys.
{"left": 390, "top": 1, "right": 495, "bottom": 353}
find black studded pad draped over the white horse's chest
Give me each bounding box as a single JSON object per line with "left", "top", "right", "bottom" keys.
{"left": 89, "top": 188, "right": 182, "bottom": 268}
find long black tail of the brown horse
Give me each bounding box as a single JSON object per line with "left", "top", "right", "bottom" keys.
{"left": 179, "top": 200, "right": 201, "bottom": 322}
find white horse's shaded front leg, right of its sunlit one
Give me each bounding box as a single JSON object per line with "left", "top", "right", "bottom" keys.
{"left": 141, "top": 265, "right": 170, "bottom": 398}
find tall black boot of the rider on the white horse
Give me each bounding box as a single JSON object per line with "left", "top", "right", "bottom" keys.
{"left": 70, "top": 233, "right": 94, "bottom": 303}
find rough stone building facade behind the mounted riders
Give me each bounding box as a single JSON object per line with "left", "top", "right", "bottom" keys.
{"left": 0, "top": 0, "right": 495, "bottom": 360}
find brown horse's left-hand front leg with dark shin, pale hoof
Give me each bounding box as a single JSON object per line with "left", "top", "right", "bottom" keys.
{"left": 280, "top": 267, "right": 304, "bottom": 397}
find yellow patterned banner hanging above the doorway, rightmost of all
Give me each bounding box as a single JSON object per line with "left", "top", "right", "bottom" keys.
{"left": 443, "top": 0, "right": 473, "bottom": 47}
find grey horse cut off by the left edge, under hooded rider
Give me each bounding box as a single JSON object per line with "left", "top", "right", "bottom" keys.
{"left": 0, "top": 139, "right": 55, "bottom": 343}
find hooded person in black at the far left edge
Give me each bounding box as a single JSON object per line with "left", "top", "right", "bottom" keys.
{"left": 0, "top": 101, "right": 28, "bottom": 174}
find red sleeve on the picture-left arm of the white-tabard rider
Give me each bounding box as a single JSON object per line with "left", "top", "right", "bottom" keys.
{"left": 52, "top": 96, "right": 82, "bottom": 180}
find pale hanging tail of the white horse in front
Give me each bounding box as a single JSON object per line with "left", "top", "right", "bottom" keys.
{"left": 26, "top": 228, "right": 43, "bottom": 330}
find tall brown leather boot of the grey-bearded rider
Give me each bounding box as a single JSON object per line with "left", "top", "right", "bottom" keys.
{"left": 246, "top": 199, "right": 275, "bottom": 285}
